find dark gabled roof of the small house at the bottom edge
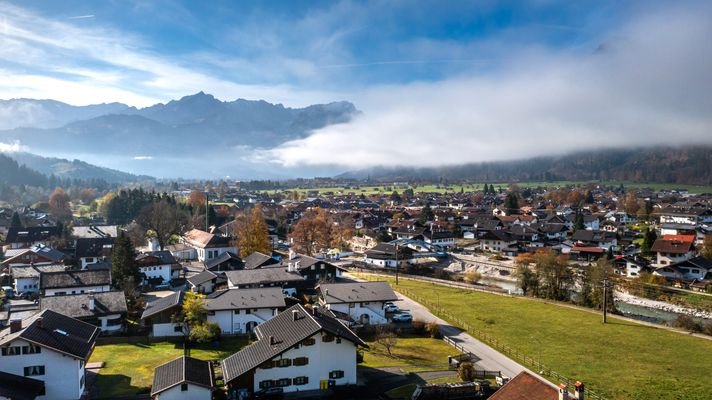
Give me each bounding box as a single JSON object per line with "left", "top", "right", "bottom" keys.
{"left": 151, "top": 356, "right": 215, "bottom": 396}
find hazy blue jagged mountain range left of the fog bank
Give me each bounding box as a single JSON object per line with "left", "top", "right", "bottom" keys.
{"left": 0, "top": 92, "right": 360, "bottom": 178}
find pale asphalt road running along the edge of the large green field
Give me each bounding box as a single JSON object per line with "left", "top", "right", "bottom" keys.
{"left": 396, "top": 292, "right": 558, "bottom": 390}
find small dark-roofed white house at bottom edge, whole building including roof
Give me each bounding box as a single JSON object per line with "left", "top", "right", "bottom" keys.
{"left": 151, "top": 356, "right": 215, "bottom": 400}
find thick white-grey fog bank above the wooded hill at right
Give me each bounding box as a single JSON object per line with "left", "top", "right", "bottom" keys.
{"left": 258, "top": 7, "right": 712, "bottom": 168}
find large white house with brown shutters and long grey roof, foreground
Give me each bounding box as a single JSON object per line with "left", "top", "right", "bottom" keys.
{"left": 222, "top": 304, "right": 368, "bottom": 393}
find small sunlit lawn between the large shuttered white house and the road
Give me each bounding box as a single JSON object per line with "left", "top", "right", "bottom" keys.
{"left": 361, "top": 335, "right": 458, "bottom": 372}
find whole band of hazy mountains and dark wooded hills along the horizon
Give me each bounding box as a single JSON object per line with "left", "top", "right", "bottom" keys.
{"left": 0, "top": 92, "right": 712, "bottom": 184}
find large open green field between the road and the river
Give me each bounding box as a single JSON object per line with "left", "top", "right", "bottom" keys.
{"left": 358, "top": 277, "right": 712, "bottom": 400}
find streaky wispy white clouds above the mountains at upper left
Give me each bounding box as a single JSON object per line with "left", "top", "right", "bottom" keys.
{"left": 0, "top": 4, "right": 340, "bottom": 106}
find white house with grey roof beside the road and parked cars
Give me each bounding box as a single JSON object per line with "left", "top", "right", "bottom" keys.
{"left": 316, "top": 282, "right": 398, "bottom": 324}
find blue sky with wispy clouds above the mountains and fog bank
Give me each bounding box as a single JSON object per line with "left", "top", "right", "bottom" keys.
{"left": 0, "top": 1, "right": 636, "bottom": 106}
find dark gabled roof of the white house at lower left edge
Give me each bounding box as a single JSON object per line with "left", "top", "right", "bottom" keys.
{"left": 0, "top": 310, "right": 100, "bottom": 360}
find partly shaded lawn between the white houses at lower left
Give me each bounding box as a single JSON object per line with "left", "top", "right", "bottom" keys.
{"left": 89, "top": 337, "right": 247, "bottom": 397}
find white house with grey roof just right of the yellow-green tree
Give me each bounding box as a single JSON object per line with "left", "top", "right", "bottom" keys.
{"left": 205, "top": 287, "right": 286, "bottom": 335}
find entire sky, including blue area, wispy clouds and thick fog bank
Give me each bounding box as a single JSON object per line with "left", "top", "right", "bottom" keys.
{"left": 0, "top": 0, "right": 712, "bottom": 168}
